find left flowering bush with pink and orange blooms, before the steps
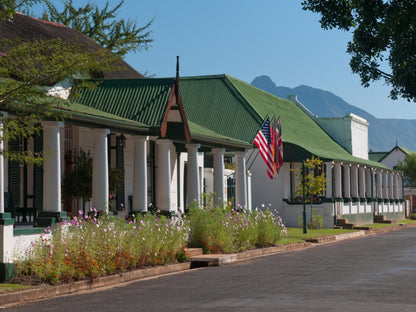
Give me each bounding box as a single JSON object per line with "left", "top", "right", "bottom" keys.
{"left": 18, "top": 211, "right": 189, "bottom": 284}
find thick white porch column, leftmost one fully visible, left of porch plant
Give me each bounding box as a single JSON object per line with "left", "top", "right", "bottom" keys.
{"left": 42, "top": 121, "right": 63, "bottom": 212}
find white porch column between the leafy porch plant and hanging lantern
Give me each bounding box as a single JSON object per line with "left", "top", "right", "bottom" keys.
{"left": 92, "top": 129, "right": 110, "bottom": 212}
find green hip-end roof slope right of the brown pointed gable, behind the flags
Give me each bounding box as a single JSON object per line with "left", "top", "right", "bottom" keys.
{"left": 179, "top": 75, "right": 263, "bottom": 147}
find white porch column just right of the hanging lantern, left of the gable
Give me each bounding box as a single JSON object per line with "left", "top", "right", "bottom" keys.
{"left": 133, "top": 136, "right": 149, "bottom": 211}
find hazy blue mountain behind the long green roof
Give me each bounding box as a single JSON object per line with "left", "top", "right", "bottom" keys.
{"left": 251, "top": 76, "right": 416, "bottom": 152}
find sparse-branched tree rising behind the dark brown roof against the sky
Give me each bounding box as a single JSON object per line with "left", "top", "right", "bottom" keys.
{"left": 42, "top": 0, "right": 153, "bottom": 57}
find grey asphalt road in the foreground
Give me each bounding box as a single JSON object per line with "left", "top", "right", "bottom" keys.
{"left": 6, "top": 228, "right": 416, "bottom": 312}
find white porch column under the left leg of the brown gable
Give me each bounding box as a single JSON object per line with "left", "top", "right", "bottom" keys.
{"left": 156, "top": 139, "right": 172, "bottom": 211}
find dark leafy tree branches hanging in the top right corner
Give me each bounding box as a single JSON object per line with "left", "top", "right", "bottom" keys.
{"left": 302, "top": 0, "right": 416, "bottom": 102}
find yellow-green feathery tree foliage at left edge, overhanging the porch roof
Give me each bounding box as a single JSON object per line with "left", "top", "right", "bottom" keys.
{"left": 0, "top": 4, "right": 120, "bottom": 164}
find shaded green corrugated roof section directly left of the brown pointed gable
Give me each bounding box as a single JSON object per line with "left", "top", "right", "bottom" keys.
{"left": 70, "top": 78, "right": 174, "bottom": 126}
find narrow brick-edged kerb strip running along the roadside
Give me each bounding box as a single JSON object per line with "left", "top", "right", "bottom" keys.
{"left": 0, "top": 223, "right": 416, "bottom": 308}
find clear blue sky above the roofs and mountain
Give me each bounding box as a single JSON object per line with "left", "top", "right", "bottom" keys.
{"left": 38, "top": 0, "right": 416, "bottom": 119}
